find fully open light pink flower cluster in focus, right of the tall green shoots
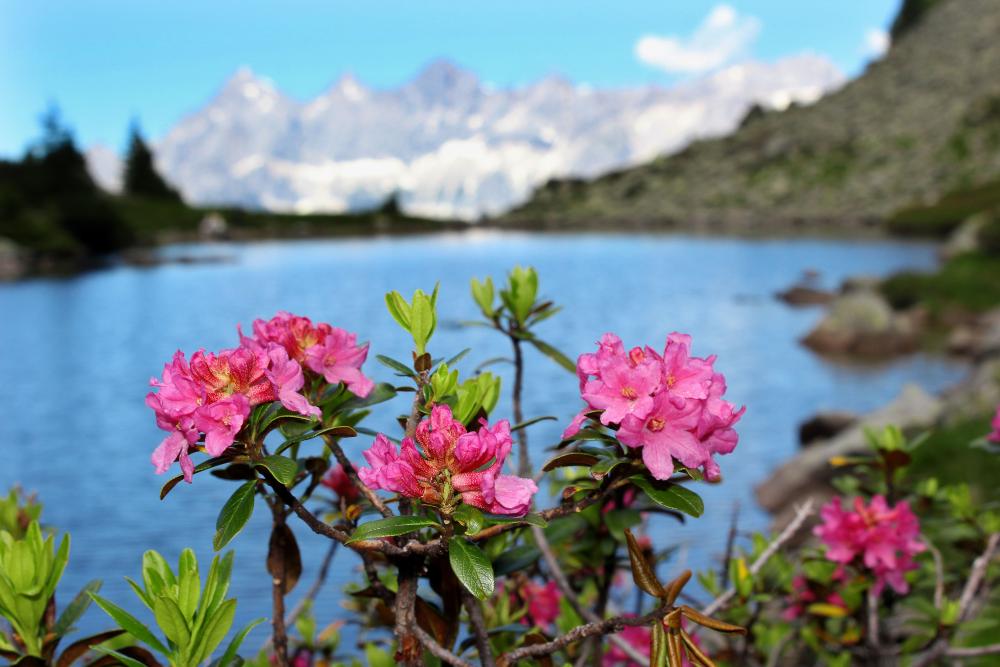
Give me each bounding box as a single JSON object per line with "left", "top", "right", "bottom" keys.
{"left": 563, "top": 333, "right": 745, "bottom": 480}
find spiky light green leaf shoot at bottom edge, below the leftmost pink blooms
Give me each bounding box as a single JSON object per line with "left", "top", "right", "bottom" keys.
{"left": 91, "top": 549, "right": 264, "bottom": 667}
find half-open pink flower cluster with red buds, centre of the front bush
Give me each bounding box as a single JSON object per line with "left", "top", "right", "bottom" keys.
{"left": 358, "top": 405, "right": 538, "bottom": 516}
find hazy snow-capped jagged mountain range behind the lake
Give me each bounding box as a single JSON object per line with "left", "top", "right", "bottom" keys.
{"left": 95, "top": 55, "right": 844, "bottom": 218}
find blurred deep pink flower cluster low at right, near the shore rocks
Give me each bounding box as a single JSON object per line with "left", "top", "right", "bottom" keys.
{"left": 813, "top": 496, "right": 926, "bottom": 594}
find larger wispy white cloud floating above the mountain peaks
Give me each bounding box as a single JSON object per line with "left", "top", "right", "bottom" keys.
{"left": 635, "top": 5, "right": 761, "bottom": 74}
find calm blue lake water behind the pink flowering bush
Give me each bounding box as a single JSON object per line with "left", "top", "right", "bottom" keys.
{"left": 0, "top": 232, "right": 964, "bottom": 646}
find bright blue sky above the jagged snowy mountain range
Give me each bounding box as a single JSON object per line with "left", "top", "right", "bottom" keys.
{"left": 0, "top": 0, "right": 900, "bottom": 157}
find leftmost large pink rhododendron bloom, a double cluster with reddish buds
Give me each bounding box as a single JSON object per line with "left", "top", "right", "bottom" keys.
{"left": 146, "top": 313, "right": 372, "bottom": 482}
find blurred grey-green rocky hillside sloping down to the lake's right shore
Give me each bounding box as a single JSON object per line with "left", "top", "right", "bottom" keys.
{"left": 501, "top": 0, "right": 1000, "bottom": 231}
